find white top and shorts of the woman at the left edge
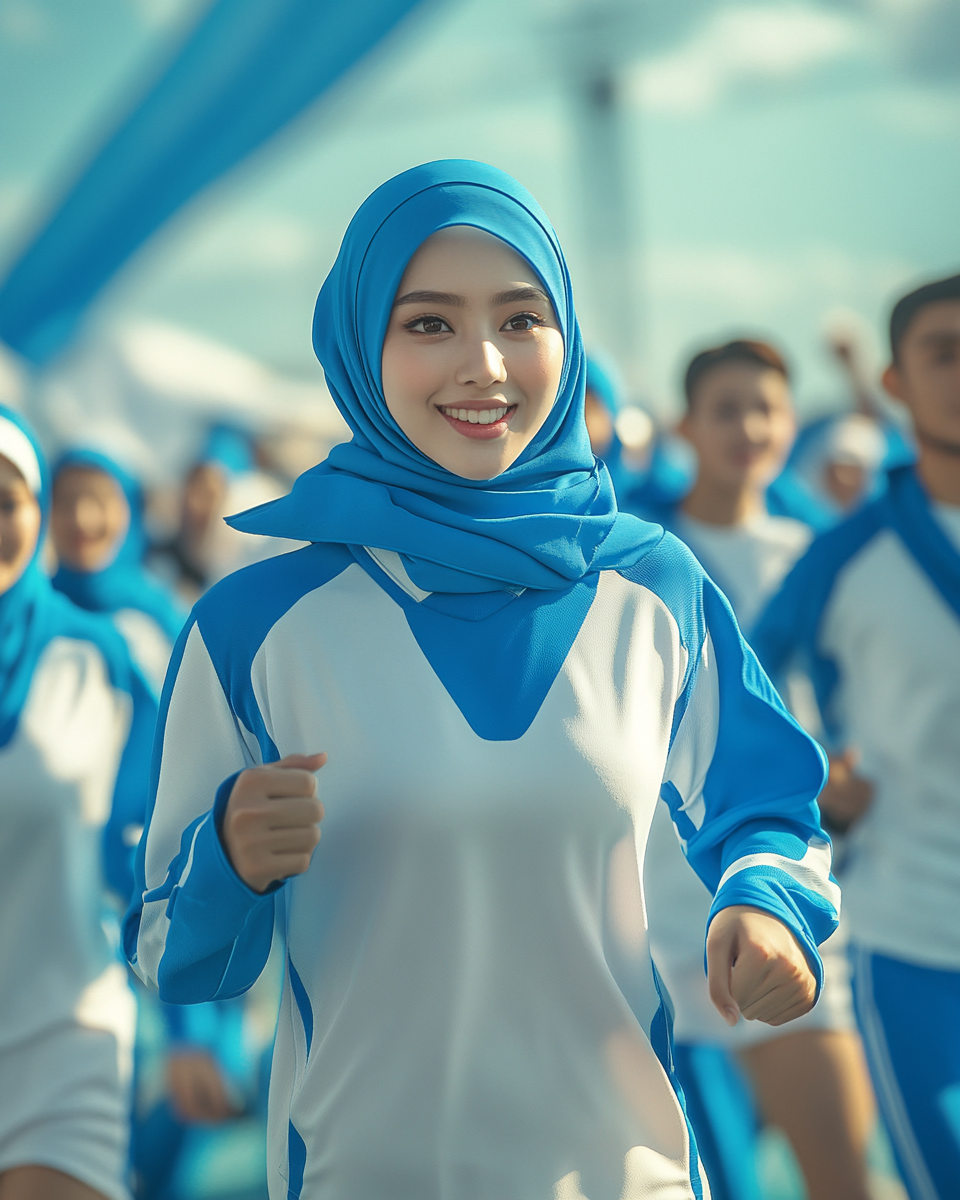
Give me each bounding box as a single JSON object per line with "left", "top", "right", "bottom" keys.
{"left": 0, "top": 637, "right": 136, "bottom": 1200}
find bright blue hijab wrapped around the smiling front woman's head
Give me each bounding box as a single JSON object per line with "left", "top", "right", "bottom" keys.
{"left": 229, "top": 160, "right": 661, "bottom": 594}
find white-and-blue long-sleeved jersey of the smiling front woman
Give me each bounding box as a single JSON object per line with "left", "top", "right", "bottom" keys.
{"left": 125, "top": 535, "right": 839, "bottom": 1200}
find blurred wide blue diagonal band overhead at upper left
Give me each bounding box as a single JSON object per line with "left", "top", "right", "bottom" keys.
{"left": 0, "top": 0, "right": 420, "bottom": 364}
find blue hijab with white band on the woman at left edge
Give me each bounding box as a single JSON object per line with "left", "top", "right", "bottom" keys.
{"left": 0, "top": 404, "right": 132, "bottom": 746}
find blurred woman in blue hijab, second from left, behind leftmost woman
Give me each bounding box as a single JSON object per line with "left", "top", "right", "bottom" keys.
{"left": 50, "top": 448, "right": 184, "bottom": 695}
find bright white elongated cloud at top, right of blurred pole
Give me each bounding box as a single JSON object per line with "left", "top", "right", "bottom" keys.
{"left": 631, "top": 4, "right": 863, "bottom": 113}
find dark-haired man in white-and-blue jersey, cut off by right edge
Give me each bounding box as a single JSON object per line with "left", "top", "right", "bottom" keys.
{"left": 752, "top": 276, "right": 960, "bottom": 1200}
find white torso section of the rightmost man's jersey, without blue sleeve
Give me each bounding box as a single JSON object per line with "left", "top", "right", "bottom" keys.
{"left": 820, "top": 525, "right": 960, "bottom": 970}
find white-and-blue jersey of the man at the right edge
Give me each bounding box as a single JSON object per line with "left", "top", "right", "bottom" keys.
{"left": 752, "top": 468, "right": 960, "bottom": 971}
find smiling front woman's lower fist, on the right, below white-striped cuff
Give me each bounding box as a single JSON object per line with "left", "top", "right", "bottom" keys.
{"left": 707, "top": 905, "right": 817, "bottom": 1025}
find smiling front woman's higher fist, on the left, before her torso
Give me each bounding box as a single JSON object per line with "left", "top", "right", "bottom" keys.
{"left": 221, "top": 754, "right": 326, "bottom": 893}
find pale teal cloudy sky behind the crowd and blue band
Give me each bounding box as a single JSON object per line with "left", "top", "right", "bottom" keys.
{"left": 0, "top": 0, "right": 960, "bottom": 412}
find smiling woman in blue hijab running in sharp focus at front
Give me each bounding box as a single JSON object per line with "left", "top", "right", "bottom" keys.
{"left": 125, "top": 161, "right": 838, "bottom": 1200}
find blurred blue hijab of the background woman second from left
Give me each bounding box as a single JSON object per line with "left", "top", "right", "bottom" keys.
{"left": 53, "top": 449, "right": 184, "bottom": 642}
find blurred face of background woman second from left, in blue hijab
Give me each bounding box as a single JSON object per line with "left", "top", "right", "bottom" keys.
{"left": 50, "top": 467, "right": 130, "bottom": 572}
